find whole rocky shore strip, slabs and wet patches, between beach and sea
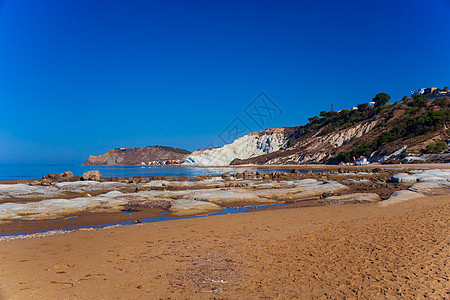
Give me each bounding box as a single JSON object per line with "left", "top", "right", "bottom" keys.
{"left": 0, "top": 164, "right": 450, "bottom": 235}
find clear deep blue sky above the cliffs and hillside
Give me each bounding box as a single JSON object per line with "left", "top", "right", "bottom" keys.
{"left": 0, "top": 0, "right": 450, "bottom": 164}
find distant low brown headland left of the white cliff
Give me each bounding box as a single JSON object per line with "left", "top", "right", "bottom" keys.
{"left": 83, "top": 146, "right": 190, "bottom": 166}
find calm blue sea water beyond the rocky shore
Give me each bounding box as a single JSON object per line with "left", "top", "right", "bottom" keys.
{"left": 0, "top": 165, "right": 298, "bottom": 181}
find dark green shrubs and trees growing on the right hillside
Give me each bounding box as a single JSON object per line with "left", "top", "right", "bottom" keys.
{"left": 289, "top": 88, "right": 450, "bottom": 163}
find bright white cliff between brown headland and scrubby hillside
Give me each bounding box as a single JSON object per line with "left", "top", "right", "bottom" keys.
{"left": 183, "top": 128, "right": 292, "bottom": 166}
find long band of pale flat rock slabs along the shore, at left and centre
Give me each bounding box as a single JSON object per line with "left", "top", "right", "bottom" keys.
{"left": 0, "top": 179, "right": 347, "bottom": 224}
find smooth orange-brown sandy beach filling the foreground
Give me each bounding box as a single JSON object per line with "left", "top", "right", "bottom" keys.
{"left": 0, "top": 195, "right": 450, "bottom": 299}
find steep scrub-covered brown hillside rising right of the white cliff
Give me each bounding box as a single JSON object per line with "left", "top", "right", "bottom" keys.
{"left": 231, "top": 95, "right": 450, "bottom": 165}
